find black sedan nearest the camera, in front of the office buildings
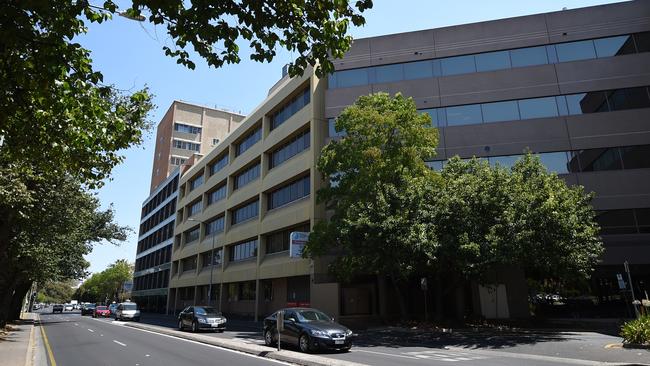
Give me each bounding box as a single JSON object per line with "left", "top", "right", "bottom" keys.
{"left": 263, "top": 308, "right": 352, "bottom": 352}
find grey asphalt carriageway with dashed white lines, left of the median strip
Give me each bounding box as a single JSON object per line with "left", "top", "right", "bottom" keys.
{"left": 40, "top": 311, "right": 286, "bottom": 366}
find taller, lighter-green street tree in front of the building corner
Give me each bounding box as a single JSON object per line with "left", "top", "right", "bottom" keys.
{"left": 304, "top": 93, "right": 438, "bottom": 316}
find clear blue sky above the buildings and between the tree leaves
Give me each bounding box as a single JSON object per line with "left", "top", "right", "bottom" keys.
{"left": 79, "top": 0, "right": 618, "bottom": 272}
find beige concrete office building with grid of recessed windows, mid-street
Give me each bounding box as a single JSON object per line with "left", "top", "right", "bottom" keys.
{"left": 168, "top": 69, "right": 338, "bottom": 318}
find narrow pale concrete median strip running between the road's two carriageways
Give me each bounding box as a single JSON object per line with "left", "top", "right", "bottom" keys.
{"left": 124, "top": 322, "right": 365, "bottom": 366}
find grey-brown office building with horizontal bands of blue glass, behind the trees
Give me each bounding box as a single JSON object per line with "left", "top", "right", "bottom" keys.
{"left": 325, "top": 0, "right": 650, "bottom": 316}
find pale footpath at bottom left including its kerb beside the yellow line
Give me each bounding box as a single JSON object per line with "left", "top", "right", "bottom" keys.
{"left": 0, "top": 313, "right": 47, "bottom": 366}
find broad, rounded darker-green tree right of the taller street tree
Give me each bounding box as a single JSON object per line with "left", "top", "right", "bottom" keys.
{"left": 429, "top": 153, "right": 603, "bottom": 317}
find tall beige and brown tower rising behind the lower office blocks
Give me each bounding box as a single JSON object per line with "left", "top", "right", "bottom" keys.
{"left": 150, "top": 100, "right": 244, "bottom": 192}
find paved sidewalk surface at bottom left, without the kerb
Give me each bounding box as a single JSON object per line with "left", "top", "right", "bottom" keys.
{"left": 0, "top": 313, "right": 35, "bottom": 366}
